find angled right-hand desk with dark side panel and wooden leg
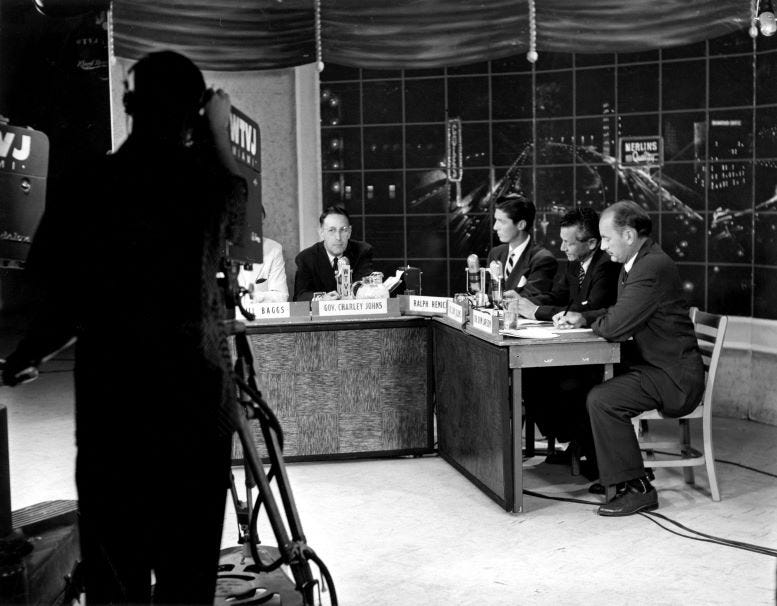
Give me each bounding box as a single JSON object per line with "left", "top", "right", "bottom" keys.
{"left": 432, "top": 318, "right": 620, "bottom": 512}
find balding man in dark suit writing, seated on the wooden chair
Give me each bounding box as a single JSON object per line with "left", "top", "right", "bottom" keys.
{"left": 554, "top": 201, "right": 704, "bottom": 516}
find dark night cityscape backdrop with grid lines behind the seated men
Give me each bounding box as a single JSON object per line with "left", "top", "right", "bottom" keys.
{"left": 321, "top": 31, "right": 777, "bottom": 318}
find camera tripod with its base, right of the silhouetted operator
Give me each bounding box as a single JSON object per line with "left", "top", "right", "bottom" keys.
{"left": 220, "top": 320, "right": 337, "bottom": 606}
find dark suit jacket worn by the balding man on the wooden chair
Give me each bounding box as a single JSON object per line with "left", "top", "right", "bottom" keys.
{"left": 583, "top": 238, "right": 704, "bottom": 416}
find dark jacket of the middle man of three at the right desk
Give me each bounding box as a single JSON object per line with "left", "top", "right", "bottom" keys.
{"left": 531, "top": 248, "right": 621, "bottom": 320}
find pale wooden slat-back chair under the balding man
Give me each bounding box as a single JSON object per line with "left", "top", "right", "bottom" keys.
{"left": 632, "top": 307, "right": 728, "bottom": 501}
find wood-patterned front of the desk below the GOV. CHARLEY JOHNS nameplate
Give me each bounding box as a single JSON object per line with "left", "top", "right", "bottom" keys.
{"left": 232, "top": 316, "right": 434, "bottom": 461}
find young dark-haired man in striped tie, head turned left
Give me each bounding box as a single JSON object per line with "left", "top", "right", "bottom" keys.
{"left": 487, "top": 193, "right": 558, "bottom": 299}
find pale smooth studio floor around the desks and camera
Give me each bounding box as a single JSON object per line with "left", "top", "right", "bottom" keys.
{"left": 0, "top": 354, "right": 777, "bottom": 606}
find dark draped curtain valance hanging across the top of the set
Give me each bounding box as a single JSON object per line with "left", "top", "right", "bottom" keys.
{"left": 113, "top": 0, "right": 750, "bottom": 71}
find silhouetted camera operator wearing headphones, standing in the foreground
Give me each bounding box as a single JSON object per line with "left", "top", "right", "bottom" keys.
{"left": 3, "top": 51, "right": 247, "bottom": 605}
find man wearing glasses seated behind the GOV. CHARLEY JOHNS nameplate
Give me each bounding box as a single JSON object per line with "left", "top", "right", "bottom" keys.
{"left": 293, "top": 206, "right": 373, "bottom": 301}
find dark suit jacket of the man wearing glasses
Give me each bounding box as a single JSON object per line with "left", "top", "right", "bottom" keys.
{"left": 294, "top": 240, "right": 373, "bottom": 301}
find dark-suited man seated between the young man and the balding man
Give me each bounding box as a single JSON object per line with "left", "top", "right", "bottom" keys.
{"left": 518, "top": 208, "right": 621, "bottom": 479}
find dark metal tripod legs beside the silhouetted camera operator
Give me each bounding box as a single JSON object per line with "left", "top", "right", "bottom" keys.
{"left": 225, "top": 321, "right": 337, "bottom": 606}
